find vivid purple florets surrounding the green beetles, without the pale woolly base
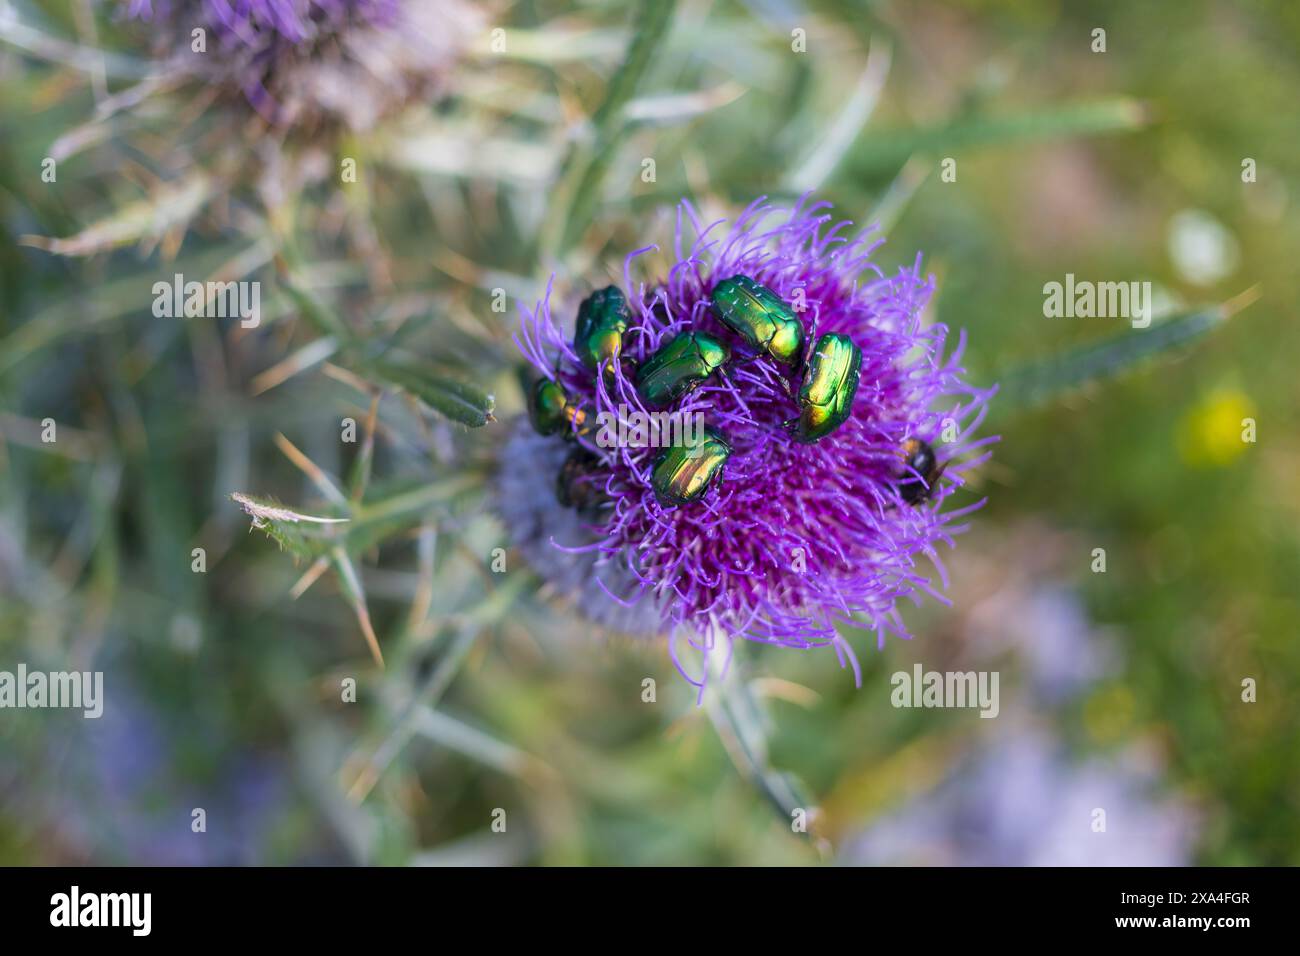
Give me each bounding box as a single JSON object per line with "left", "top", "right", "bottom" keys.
{"left": 506, "top": 200, "right": 996, "bottom": 688}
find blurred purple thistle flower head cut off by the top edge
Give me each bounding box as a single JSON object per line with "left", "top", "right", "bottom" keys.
{"left": 126, "top": 0, "right": 484, "bottom": 131}
